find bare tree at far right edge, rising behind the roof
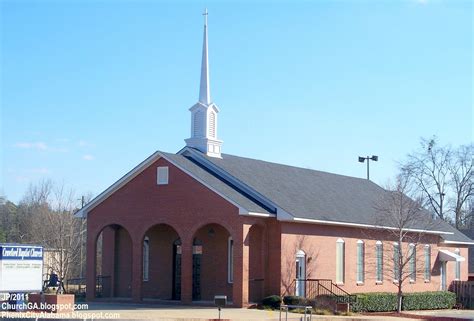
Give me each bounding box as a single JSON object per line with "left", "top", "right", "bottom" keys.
{"left": 449, "top": 144, "right": 474, "bottom": 228}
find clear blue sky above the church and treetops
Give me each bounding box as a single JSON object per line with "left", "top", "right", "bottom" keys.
{"left": 0, "top": 0, "right": 473, "bottom": 201}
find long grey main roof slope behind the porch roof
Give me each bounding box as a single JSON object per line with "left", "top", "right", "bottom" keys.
{"left": 183, "top": 150, "right": 473, "bottom": 244}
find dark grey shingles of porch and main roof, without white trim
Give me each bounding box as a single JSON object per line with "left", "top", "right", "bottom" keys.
{"left": 161, "top": 152, "right": 472, "bottom": 242}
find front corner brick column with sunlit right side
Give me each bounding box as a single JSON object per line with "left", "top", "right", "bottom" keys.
{"left": 232, "top": 224, "right": 251, "bottom": 307}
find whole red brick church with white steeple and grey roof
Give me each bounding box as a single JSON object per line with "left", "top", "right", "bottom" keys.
{"left": 78, "top": 11, "right": 472, "bottom": 307}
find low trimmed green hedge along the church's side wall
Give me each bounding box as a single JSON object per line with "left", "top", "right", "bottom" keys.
{"left": 351, "top": 291, "right": 456, "bottom": 312}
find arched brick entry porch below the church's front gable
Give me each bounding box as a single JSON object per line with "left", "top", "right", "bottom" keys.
{"left": 86, "top": 221, "right": 267, "bottom": 307}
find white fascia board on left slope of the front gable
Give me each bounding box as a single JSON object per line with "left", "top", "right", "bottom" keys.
{"left": 74, "top": 152, "right": 161, "bottom": 217}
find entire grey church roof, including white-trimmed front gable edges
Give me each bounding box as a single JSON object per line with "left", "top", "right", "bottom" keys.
{"left": 76, "top": 148, "right": 474, "bottom": 244}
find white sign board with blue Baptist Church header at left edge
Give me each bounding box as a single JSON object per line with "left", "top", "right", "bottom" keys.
{"left": 0, "top": 244, "right": 43, "bottom": 293}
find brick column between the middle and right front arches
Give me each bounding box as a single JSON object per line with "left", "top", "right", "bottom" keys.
{"left": 181, "top": 238, "right": 193, "bottom": 304}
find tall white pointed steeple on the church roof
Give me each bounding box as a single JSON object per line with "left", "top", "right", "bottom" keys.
{"left": 185, "top": 9, "right": 222, "bottom": 157}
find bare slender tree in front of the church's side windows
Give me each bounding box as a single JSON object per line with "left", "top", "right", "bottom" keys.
{"left": 374, "top": 175, "right": 438, "bottom": 312}
